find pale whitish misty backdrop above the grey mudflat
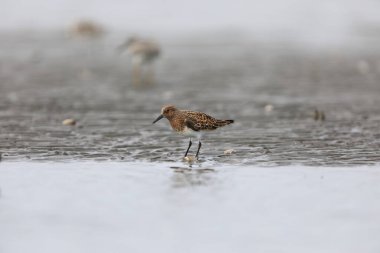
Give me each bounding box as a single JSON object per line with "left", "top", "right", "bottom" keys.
{"left": 0, "top": 0, "right": 380, "bottom": 45}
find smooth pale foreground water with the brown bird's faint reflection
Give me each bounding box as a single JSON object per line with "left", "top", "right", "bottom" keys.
{"left": 0, "top": 162, "right": 380, "bottom": 253}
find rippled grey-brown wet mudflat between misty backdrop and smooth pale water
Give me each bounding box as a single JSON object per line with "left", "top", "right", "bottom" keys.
{"left": 0, "top": 33, "right": 380, "bottom": 166}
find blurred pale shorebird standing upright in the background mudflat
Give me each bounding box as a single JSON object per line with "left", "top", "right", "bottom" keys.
{"left": 117, "top": 37, "right": 161, "bottom": 85}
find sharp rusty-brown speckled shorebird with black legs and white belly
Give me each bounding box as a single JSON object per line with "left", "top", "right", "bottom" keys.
{"left": 153, "top": 105, "right": 234, "bottom": 159}
